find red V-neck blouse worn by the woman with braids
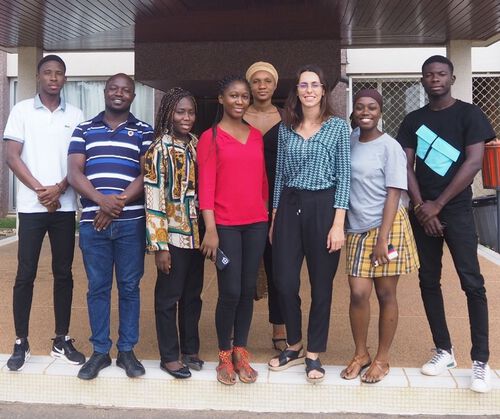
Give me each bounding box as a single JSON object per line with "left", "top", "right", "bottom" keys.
{"left": 197, "top": 126, "right": 269, "bottom": 225}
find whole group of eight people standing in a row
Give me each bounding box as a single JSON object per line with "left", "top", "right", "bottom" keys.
{"left": 5, "top": 55, "right": 495, "bottom": 392}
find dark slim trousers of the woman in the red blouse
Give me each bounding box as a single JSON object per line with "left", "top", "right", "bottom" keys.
{"left": 215, "top": 222, "right": 268, "bottom": 351}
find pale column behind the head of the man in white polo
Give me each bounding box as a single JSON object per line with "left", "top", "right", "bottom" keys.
{"left": 17, "top": 47, "right": 43, "bottom": 102}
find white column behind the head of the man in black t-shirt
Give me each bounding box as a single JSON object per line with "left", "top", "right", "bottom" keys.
{"left": 446, "top": 40, "right": 472, "bottom": 103}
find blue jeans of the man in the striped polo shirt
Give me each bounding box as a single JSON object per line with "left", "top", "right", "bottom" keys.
{"left": 80, "top": 218, "right": 146, "bottom": 353}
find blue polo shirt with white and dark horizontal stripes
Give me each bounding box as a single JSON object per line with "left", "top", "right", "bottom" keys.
{"left": 68, "top": 112, "right": 153, "bottom": 222}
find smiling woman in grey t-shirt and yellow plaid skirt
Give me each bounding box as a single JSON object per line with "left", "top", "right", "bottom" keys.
{"left": 340, "top": 89, "right": 418, "bottom": 383}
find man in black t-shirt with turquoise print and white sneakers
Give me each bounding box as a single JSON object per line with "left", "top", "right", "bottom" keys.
{"left": 398, "top": 55, "right": 495, "bottom": 392}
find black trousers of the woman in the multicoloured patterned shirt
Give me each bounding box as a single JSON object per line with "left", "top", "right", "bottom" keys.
{"left": 155, "top": 245, "right": 205, "bottom": 362}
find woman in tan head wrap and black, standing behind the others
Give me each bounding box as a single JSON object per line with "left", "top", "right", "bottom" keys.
{"left": 244, "top": 61, "right": 286, "bottom": 351}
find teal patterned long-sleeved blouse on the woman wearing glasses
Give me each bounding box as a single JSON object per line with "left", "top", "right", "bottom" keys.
{"left": 273, "top": 117, "right": 351, "bottom": 209}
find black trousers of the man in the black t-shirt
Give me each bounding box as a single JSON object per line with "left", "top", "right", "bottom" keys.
{"left": 410, "top": 202, "right": 489, "bottom": 362}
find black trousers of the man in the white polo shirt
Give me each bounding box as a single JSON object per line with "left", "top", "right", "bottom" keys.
{"left": 13, "top": 211, "right": 75, "bottom": 338}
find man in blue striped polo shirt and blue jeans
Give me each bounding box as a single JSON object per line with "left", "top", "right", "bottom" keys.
{"left": 68, "top": 73, "right": 153, "bottom": 380}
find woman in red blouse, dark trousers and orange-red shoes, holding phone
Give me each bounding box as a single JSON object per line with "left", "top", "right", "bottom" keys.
{"left": 198, "top": 76, "right": 268, "bottom": 384}
